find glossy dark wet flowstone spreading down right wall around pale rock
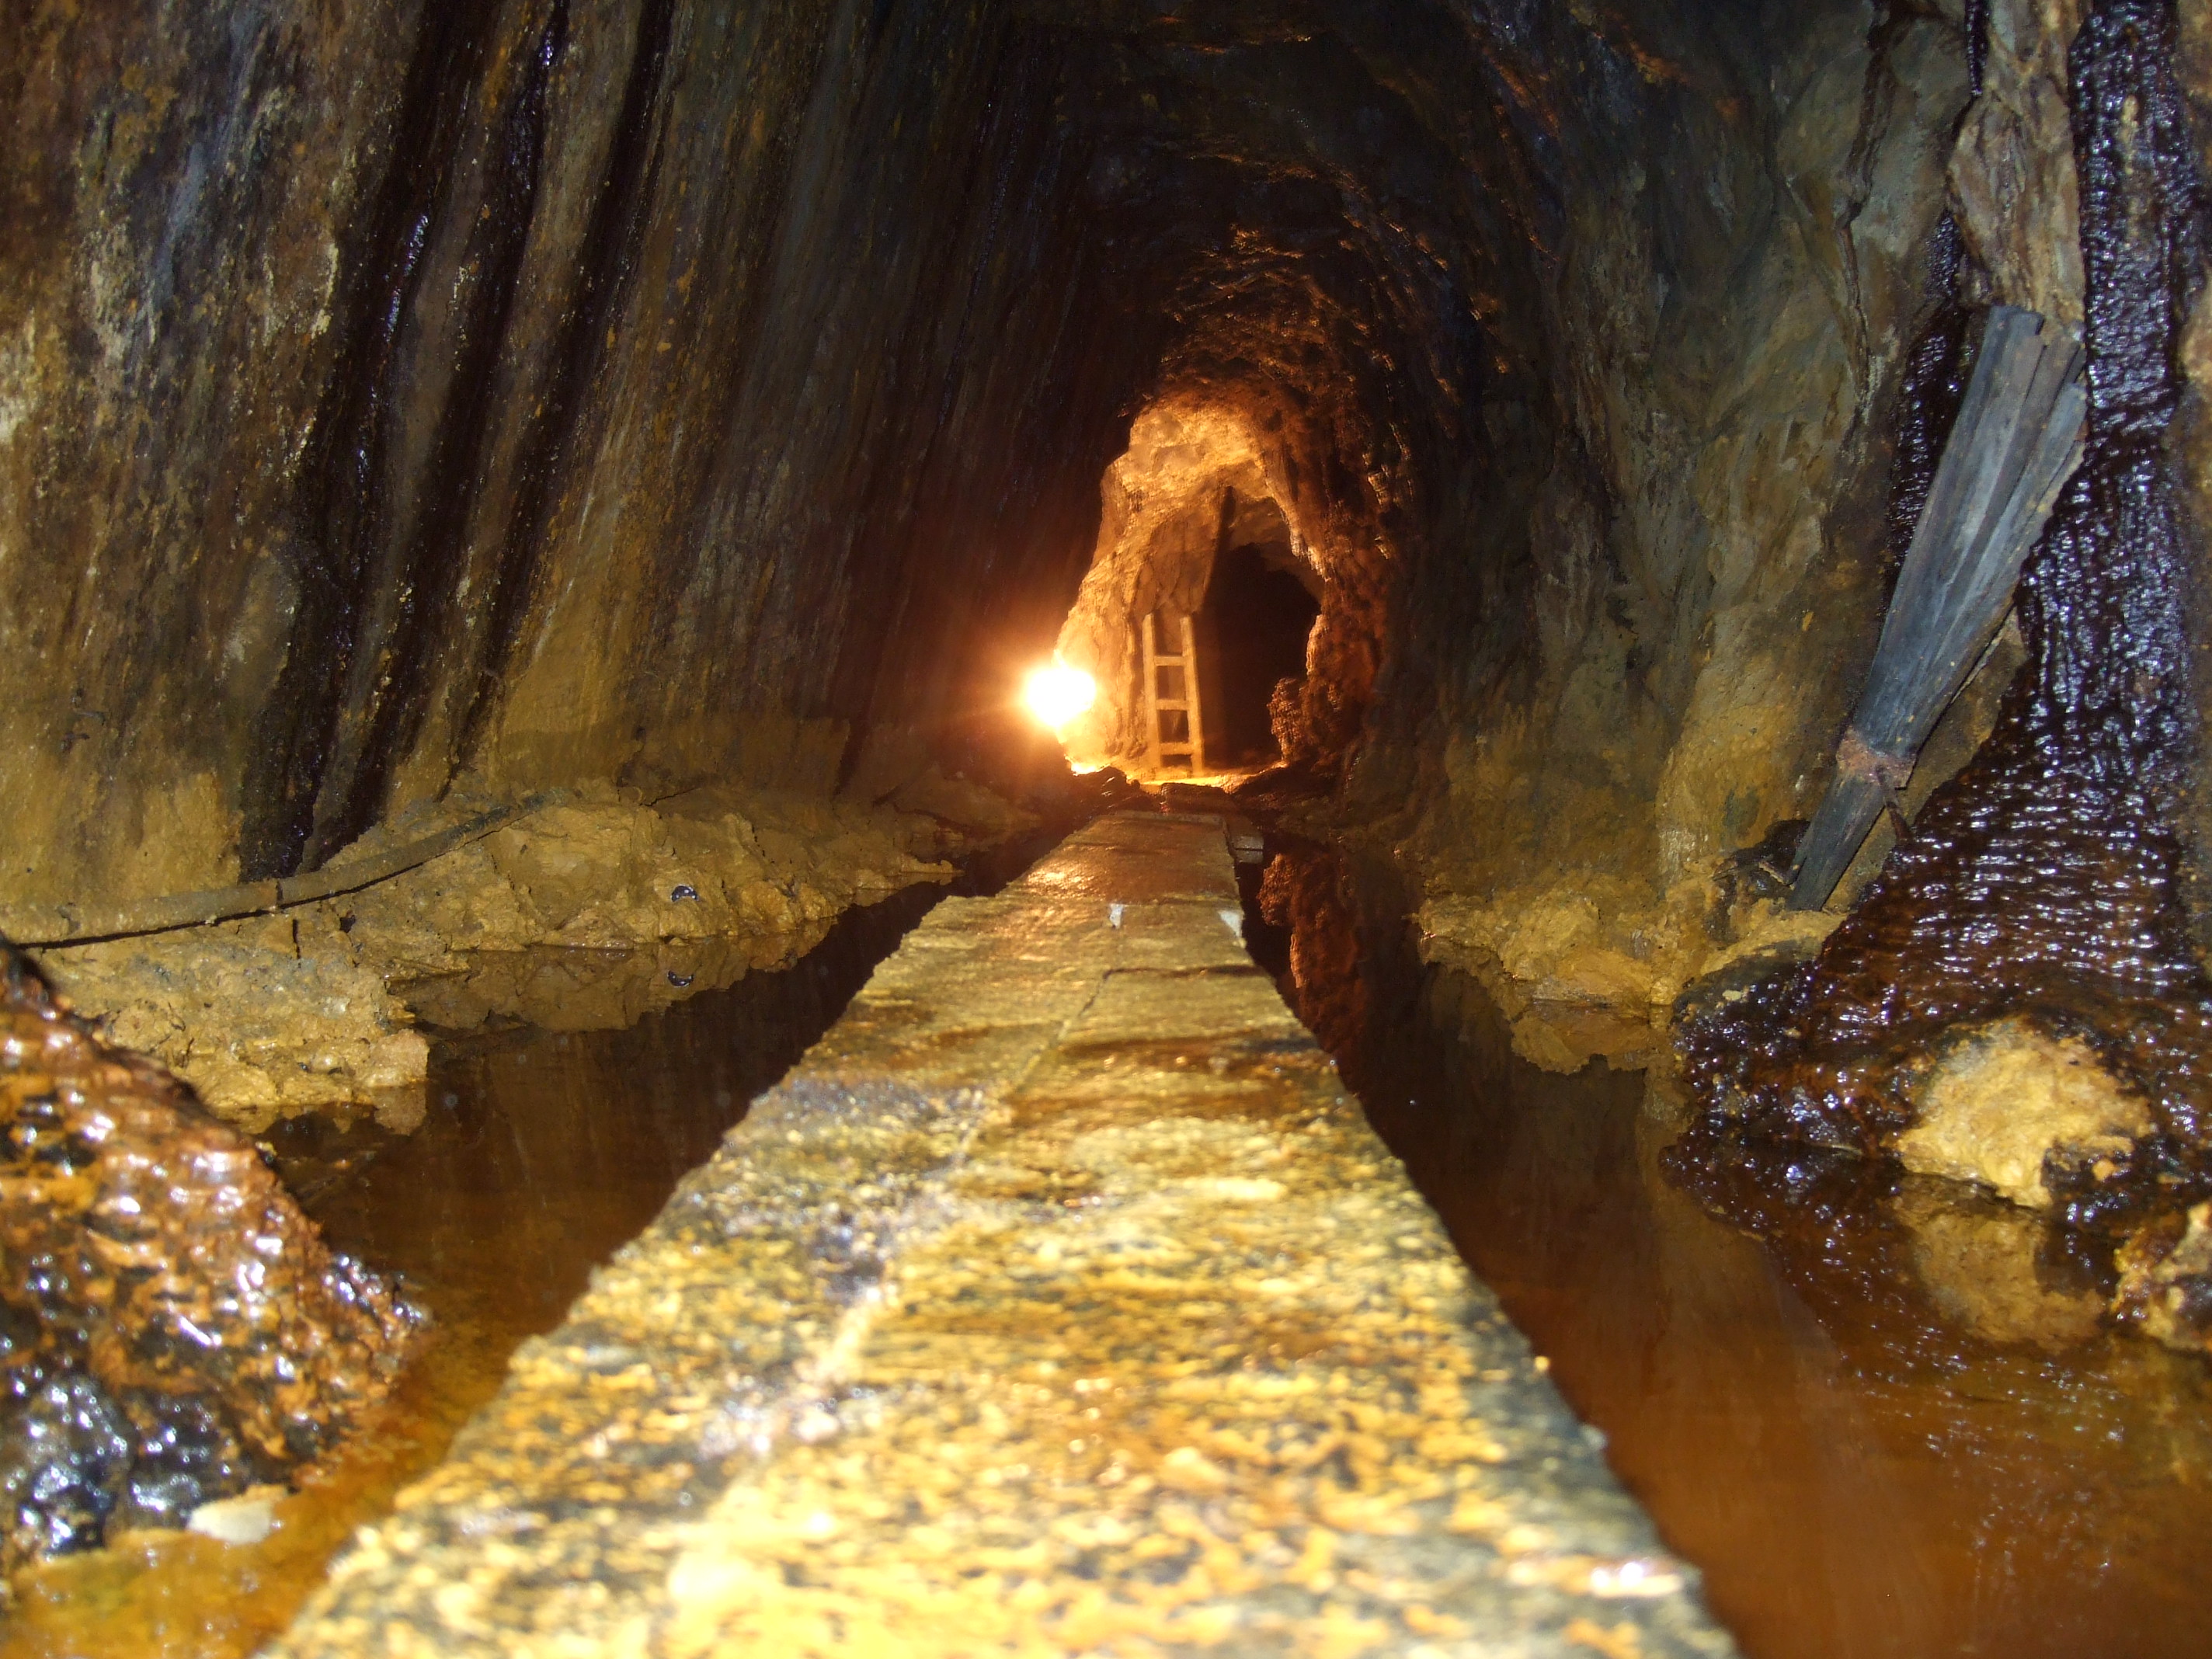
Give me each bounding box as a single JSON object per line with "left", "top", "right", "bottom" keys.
{"left": 1683, "top": 0, "right": 2212, "bottom": 1314}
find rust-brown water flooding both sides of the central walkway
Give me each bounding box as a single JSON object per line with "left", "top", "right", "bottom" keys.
{"left": 0, "top": 836, "right": 2212, "bottom": 1659}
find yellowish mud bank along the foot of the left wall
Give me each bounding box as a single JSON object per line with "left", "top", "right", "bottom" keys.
{"left": 19, "top": 770, "right": 986, "bottom": 1132}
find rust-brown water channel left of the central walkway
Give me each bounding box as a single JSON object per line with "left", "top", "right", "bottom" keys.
{"left": 0, "top": 887, "right": 942, "bottom": 1659}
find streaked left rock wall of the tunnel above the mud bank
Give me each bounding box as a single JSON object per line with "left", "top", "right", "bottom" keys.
{"left": 0, "top": 0, "right": 1122, "bottom": 900}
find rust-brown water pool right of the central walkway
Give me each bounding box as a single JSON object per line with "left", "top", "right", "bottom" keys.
{"left": 1245, "top": 843, "right": 2212, "bottom": 1659}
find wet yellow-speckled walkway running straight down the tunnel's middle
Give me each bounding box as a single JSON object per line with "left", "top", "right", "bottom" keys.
{"left": 272, "top": 816, "right": 1734, "bottom": 1659}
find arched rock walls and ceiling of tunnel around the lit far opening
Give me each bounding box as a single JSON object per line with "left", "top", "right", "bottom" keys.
{"left": 17, "top": 0, "right": 2201, "bottom": 1149}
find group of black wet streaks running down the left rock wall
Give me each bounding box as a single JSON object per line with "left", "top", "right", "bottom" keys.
{"left": 241, "top": 0, "right": 673, "bottom": 881}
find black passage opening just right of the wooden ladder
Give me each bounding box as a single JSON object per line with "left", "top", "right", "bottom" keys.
{"left": 1197, "top": 544, "right": 1320, "bottom": 767}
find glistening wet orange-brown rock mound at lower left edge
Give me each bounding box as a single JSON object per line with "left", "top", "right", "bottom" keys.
{"left": 0, "top": 951, "right": 412, "bottom": 1570}
